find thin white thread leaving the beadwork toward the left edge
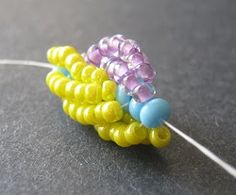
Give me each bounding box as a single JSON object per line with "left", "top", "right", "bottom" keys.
{"left": 0, "top": 59, "right": 55, "bottom": 69}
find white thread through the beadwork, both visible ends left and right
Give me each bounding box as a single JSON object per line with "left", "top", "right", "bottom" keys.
{"left": 0, "top": 59, "right": 236, "bottom": 178}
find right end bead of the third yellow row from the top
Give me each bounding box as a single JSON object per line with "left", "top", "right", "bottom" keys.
{"left": 102, "top": 101, "right": 123, "bottom": 123}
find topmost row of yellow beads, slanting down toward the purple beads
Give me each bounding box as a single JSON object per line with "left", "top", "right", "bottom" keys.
{"left": 47, "top": 46, "right": 109, "bottom": 83}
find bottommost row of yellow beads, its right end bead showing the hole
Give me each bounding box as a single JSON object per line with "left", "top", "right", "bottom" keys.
{"left": 95, "top": 116, "right": 171, "bottom": 148}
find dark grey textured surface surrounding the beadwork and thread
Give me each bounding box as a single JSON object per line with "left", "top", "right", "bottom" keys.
{"left": 0, "top": 0, "right": 236, "bottom": 194}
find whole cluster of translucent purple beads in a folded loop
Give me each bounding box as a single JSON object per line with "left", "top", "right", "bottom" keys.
{"left": 84, "top": 35, "right": 156, "bottom": 102}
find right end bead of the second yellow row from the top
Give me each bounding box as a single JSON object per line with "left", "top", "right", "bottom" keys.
{"left": 102, "top": 80, "right": 116, "bottom": 101}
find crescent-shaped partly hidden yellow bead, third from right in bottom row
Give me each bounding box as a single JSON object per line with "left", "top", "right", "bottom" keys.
{"left": 113, "top": 124, "right": 131, "bottom": 147}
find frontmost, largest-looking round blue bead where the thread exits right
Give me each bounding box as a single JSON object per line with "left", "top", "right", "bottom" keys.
{"left": 140, "top": 98, "right": 170, "bottom": 128}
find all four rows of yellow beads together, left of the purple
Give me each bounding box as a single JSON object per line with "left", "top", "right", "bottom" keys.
{"left": 46, "top": 46, "right": 170, "bottom": 148}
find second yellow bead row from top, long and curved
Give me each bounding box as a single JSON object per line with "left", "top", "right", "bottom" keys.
{"left": 46, "top": 70, "right": 116, "bottom": 104}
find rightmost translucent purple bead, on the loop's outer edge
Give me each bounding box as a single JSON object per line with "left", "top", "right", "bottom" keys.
{"left": 135, "top": 63, "right": 156, "bottom": 83}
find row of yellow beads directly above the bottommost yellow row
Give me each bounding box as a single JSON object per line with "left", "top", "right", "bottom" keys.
{"left": 63, "top": 99, "right": 123, "bottom": 125}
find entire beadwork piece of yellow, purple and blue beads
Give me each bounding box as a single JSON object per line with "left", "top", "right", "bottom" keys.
{"left": 46, "top": 35, "right": 171, "bottom": 148}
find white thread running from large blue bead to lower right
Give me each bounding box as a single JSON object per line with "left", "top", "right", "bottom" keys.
{"left": 164, "top": 121, "right": 236, "bottom": 178}
